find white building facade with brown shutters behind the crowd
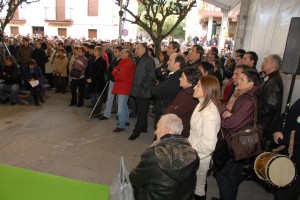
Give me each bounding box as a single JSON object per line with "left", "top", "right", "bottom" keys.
{"left": 1, "top": 0, "right": 138, "bottom": 41}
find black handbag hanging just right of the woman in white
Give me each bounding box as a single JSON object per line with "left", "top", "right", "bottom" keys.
{"left": 212, "top": 128, "right": 231, "bottom": 170}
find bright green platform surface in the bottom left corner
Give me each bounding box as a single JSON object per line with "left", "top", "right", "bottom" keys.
{"left": 0, "top": 165, "right": 109, "bottom": 200}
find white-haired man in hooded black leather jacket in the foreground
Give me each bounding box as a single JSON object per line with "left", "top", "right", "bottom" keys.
{"left": 129, "top": 114, "right": 199, "bottom": 200}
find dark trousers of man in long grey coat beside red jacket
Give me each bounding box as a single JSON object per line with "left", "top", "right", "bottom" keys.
{"left": 134, "top": 97, "right": 150, "bottom": 133}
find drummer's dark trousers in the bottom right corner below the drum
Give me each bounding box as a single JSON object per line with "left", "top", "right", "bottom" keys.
{"left": 274, "top": 176, "right": 300, "bottom": 200}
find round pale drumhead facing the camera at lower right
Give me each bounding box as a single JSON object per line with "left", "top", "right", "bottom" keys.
{"left": 267, "top": 156, "right": 296, "bottom": 187}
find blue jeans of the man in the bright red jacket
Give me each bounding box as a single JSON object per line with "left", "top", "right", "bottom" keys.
{"left": 117, "top": 94, "right": 129, "bottom": 128}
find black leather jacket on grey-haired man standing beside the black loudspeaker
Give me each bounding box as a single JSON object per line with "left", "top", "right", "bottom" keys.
{"left": 257, "top": 71, "right": 283, "bottom": 137}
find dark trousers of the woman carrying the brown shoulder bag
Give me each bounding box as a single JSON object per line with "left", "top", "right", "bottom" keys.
{"left": 216, "top": 159, "right": 243, "bottom": 200}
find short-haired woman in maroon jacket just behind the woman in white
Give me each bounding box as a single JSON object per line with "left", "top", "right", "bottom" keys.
{"left": 164, "top": 67, "right": 200, "bottom": 138}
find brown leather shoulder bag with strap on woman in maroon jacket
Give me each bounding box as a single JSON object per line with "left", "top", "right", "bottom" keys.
{"left": 230, "top": 97, "right": 263, "bottom": 161}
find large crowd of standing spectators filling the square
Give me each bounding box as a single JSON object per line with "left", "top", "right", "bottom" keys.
{"left": 0, "top": 34, "right": 300, "bottom": 200}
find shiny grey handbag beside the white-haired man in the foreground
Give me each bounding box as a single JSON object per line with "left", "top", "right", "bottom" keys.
{"left": 110, "top": 157, "right": 134, "bottom": 200}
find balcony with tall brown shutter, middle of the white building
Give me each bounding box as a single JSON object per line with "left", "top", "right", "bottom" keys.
{"left": 44, "top": 7, "right": 73, "bottom": 25}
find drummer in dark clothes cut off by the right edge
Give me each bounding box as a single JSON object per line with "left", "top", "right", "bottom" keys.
{"left": 273, "top": 99, "right": 300, "bottom": 200}
